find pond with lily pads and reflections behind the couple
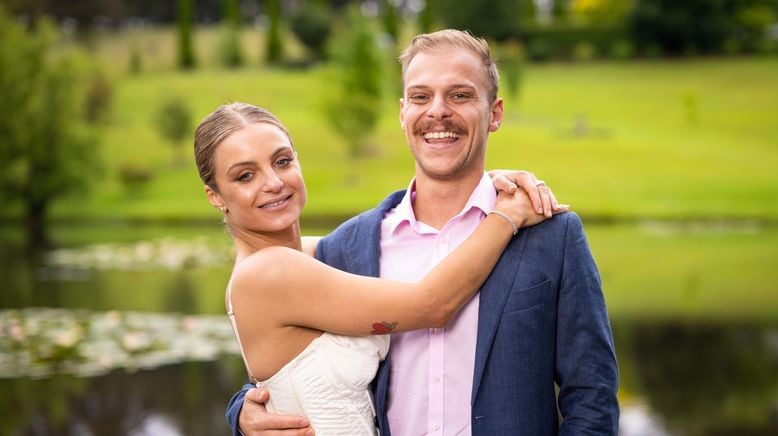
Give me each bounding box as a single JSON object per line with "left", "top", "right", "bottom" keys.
{"left": 0, "top": 226, "right": 778, "bottom": 436}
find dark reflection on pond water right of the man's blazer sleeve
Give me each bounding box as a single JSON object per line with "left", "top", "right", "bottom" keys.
{"left": 613, "top": 322, "right": 778, "bottom": 436}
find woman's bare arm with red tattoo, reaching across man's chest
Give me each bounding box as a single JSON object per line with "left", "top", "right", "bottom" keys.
{"left": 232, "top": 192, "right": 544, "bottom": 335}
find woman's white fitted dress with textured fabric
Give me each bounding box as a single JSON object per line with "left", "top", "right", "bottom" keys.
{"left": 257, "top": 332, "right": 389, "bottom": 436}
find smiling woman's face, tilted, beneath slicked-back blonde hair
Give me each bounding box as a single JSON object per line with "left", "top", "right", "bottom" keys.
{"left": 206, "top": 123, "right": 306, "bottom": 233}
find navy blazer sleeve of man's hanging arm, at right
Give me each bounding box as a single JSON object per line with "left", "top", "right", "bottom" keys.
{"left": 556, "top": 213, "right": 619, "bottom": 436}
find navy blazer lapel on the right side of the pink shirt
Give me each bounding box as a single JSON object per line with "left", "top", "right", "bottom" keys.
{"left": 470, "top": 236, "right": 524, "bottom": 406}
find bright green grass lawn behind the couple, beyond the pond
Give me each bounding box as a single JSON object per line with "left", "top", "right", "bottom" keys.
{"left": 34, "top": 29, "right": 778, "bottom": 221}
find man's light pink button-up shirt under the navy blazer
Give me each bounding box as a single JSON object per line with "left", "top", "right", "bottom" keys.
{"left": 380, "top": 174, "right": 496, "bottom": 436}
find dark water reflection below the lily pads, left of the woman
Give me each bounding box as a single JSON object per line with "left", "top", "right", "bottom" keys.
{"left": 0, "top": 359, "right": 244, "bottom": 436}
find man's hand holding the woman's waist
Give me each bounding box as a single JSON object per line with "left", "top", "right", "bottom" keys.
{"left": 238, "top": 388, "right": 313, "bottom": 436}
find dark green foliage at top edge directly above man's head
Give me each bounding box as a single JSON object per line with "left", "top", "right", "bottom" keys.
{"left": 436, "top": 0, "right": 521, "bottom": 41}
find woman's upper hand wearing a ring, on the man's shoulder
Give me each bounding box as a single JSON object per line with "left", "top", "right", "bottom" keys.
{"left": 487, "top": 170, "right": 570, "bottom": 218}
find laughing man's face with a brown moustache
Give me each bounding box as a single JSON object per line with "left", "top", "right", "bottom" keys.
{"left": 400, "top": 46, "right": 503, "bottom": 179}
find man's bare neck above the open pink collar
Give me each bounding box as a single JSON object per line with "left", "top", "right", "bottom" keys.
{"left": 413, "top": 171, "right": 483, "bottom": 229}
